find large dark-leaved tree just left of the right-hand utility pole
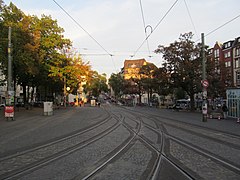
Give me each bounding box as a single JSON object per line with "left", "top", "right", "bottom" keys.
{"left": 155, "top": 32, "right": 201, "bottom": 110}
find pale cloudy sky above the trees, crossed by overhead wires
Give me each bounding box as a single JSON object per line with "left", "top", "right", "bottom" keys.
{"left": 3, "top": 0, "right": 240, "bottom": 77}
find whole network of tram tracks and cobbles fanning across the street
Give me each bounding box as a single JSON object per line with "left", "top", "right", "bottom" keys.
{"left": 0, "top": 107, "right": 240, "bottom": 180}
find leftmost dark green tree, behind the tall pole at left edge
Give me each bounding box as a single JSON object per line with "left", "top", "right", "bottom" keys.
{"left": 1, "top": 3, "right": 30, "bottom": 102}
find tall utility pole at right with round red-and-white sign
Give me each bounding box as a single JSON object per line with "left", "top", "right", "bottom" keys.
{"left": 201, "top": 33, "right": 209, "bottom": 122}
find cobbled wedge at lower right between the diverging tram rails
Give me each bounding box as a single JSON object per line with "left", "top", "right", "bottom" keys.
{"left": 163, "top": 135, "right": 240, "bottom": 179}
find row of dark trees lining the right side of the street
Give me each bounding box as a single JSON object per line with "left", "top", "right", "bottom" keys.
{"left": 109, "top": 32, "right": 226, "bottom": 108}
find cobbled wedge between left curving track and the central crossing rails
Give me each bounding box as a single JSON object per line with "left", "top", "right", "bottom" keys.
{"left": 20, "top": 126, "right": 130, "bottom": 180}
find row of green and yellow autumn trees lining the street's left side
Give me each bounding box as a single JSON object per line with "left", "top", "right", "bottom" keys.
{"left": 0, "top": 0, "right": 107, "bottom": 101}
